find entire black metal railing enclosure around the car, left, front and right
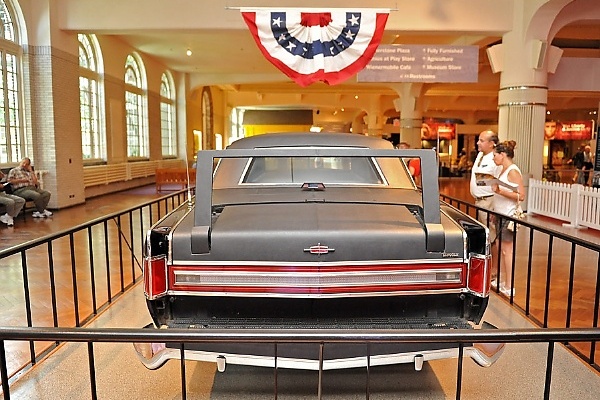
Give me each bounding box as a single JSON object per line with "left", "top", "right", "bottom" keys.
{"left": 0, "top": 191, "right": 600, "bottom": 398}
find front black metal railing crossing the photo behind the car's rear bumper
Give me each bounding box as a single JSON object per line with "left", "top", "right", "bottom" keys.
{"left": 0, "top": 328, "right": 600, "bottom": 400}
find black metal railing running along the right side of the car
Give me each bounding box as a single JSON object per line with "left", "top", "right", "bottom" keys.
{"left": 440, "top": 194, "right": 600, "bottom": 371}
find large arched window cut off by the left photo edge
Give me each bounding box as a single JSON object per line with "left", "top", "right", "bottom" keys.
{"left": 0, "top": 0, "right": 25, "bottom": 163}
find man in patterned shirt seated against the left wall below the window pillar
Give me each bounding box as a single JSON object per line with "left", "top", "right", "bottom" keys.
{"left": 8, "top": 157, "right": 52, "bottom": 218}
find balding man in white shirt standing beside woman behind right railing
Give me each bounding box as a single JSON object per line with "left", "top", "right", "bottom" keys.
{"left": 470, "top": 130, "right": 501, "bottom": 242}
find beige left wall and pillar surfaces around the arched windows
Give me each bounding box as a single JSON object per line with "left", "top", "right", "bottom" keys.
{"left": 12, "top": 0, "right": 190, "bottom": 208}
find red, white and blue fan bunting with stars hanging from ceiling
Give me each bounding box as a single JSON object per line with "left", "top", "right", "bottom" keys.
{"left": 241, "top": 8, "right": 389, "bottom": 86}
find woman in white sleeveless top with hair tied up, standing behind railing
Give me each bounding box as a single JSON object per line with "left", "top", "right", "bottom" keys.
{"left": 491, "top": 140, "right": 525, "bottom": 296}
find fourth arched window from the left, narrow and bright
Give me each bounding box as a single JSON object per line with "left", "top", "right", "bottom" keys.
{"left": 160, "top": 72, "right": 177, "bottom": 158}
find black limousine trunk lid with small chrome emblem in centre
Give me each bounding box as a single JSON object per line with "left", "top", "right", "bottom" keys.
{"left": 172, "top": 202, "right": 465, "bottom": 262}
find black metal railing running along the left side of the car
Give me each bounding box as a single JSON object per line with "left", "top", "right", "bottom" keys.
{"left": 0, "top": 190, "right": 187, "bottom": 377}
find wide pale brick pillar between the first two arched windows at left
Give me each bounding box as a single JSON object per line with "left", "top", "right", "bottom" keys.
{"left": 24, "top": 0, "right": 85, "bottom": 209}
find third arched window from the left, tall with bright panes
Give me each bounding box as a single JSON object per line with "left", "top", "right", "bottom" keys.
{"left": 125, "top": 54, "right": 149, "bottom": 159}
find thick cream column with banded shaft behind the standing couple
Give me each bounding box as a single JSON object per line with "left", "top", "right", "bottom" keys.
{"left": 487, "top": 0, "right": 562, "bottom": 186}
